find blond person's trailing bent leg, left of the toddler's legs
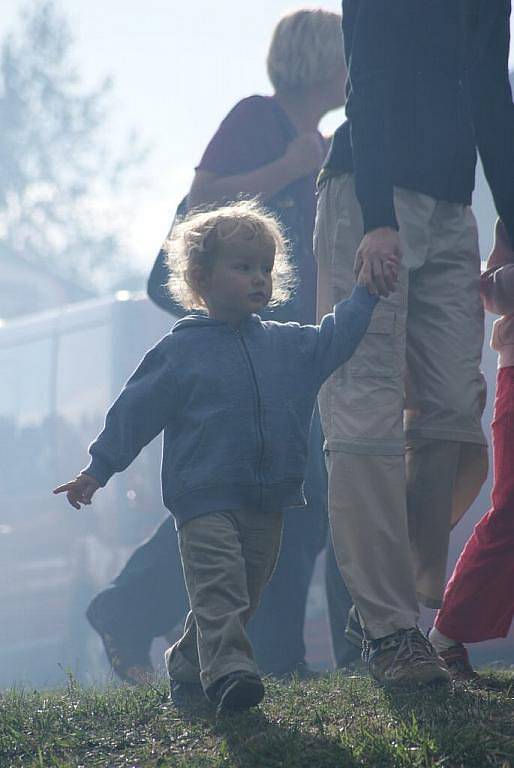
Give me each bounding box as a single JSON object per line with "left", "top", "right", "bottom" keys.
{"left": 87, "top": 515, "right": 188, "bottom": 682}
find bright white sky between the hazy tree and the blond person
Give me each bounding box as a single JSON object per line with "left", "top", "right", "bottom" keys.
{"left": 0, "top": 0, "right": 514, "bottom": 272}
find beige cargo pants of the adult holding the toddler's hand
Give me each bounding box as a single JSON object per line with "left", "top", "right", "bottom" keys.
{"left": 314, "top": 175, "right": 486, "bottom": 638}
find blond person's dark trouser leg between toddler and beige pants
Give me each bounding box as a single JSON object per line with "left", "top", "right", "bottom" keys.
{"left": 248, "top": 410, "right": 327, "bottom": 676}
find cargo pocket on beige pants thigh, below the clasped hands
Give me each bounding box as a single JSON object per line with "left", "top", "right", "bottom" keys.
{"left": 348, "top": 310, "right": 398, "bottom": 379}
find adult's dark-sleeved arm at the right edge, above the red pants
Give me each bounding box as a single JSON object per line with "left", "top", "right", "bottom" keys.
{"left": 471, "top": 0, "right": 514, "bottom": 242}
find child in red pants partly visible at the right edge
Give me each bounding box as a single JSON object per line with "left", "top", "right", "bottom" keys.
{"left": 429, "top": 221, "right": 514, "bottom": 679}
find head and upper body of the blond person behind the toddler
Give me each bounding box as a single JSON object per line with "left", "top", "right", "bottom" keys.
{"left": 188, "top": 10, "right": 345, "bottom": 322}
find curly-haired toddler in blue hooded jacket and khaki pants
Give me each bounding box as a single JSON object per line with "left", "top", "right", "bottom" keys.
{"left": 54, "top": 201, "right": 378, "bottom": 711}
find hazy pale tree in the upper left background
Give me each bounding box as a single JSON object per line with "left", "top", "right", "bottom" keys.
{"left": 0, "top": 0, "right": 146, "bottom": 291}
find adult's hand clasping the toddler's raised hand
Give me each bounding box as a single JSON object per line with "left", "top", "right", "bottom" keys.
{"left": 354, "top": 227, "right": 402, "bottom": 298}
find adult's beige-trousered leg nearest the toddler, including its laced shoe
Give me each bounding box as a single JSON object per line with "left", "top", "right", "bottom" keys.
{"left": 315, "top": 176, "right": 448, "bottom": 684}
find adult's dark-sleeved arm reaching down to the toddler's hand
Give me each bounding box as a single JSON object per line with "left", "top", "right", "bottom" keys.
{"left": 343, "top": 0, "right": 398, "bottom": 233}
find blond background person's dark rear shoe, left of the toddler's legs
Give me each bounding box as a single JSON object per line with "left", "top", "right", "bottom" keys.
{"left": 86, "top": 590, "right": 154, "bottom": 685}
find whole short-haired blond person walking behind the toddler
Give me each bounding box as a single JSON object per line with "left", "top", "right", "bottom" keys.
{"left": 88, "top": 9, "right": 357, "bottom": 682}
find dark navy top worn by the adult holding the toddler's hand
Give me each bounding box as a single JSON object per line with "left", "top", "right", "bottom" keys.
{"left": 324, "top": 0, "right": 514, "bottom": 242}
